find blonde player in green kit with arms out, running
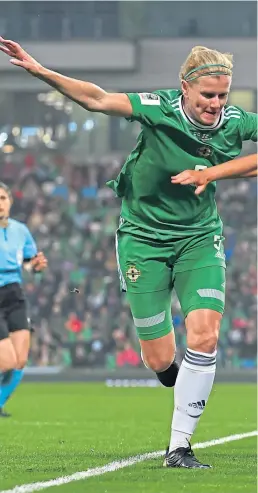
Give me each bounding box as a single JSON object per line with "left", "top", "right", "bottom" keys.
{"left": 0, "top": 38, "right": 257, "bottom": 468}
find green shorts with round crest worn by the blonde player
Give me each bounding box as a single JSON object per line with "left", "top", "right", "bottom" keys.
{"left": 116, "top": 224, "right": 226, "bottom": 340}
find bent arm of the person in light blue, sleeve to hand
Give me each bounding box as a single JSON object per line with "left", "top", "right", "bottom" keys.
{"left": 23, "top": 226, "right": 48, "bottom": 272}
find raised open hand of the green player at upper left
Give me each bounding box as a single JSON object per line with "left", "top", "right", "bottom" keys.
{"left": 0, "top": 36, "right": 41, "bottom": 75}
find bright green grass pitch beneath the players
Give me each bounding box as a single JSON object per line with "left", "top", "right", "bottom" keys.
{"left": 0, "top": 383, "right": 256, "bottom": 493}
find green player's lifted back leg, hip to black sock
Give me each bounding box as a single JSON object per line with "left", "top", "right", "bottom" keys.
{"left": 116, "top": 231, "right": 178, "bottom": 387}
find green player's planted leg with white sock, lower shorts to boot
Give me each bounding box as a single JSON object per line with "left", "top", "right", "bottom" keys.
{"left": 167, "top": 265, "right": 225, "bottom": 467}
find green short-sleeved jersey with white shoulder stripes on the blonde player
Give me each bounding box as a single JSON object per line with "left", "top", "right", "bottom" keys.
{"left": 108, "top": 90, "right": 257, "bottom": 238}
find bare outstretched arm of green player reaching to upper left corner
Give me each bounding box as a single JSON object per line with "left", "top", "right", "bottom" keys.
{"left": 0, "top": 37, "right": 133, "bottom": 117}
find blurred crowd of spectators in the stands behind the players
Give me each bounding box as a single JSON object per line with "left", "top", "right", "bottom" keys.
{"left": 0, "top": 150, "right": 257, "bottom": 369}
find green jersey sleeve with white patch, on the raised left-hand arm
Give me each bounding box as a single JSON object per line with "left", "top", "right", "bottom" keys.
{"left": 127, "top": 92, "right": 162, "bottom": 125}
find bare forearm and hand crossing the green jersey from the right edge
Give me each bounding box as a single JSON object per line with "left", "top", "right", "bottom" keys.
{"left": 171, "top": 154, "right": 257, "bottom": 195}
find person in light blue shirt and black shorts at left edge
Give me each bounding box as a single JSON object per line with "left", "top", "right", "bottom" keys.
{"left": 0, "top": 182, "right": 47, "bottom": 417}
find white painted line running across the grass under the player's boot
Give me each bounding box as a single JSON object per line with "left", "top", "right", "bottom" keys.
{"left": 1, "top": 431, "right": 258, "bottom": 493}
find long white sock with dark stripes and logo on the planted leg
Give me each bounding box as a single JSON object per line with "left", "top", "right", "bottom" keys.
{"left": 169, "top": 349, "right": 216, "bottom": 451}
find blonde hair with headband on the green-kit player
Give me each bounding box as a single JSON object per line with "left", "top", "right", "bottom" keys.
{"left": 179, "top": 46, "right": 233, "bottom": 81}
